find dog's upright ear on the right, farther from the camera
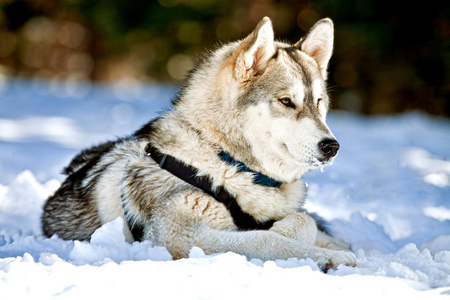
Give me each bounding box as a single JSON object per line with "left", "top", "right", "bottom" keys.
{"left": 294, "top": 18, "right": 334, "bottom": 79}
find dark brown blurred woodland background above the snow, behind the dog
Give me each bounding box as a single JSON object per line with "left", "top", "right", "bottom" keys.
{"left": 0, "top": 0, "right": 450, "bottom": 117}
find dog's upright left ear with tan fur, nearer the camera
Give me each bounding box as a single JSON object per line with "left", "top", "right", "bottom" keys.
{"left": 235, "top": 17, "right": 275, "bottom": 82}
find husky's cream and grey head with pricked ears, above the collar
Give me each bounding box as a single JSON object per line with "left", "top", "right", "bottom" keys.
{"left": 179, "top": 17, "right": 339, "bottom": 182}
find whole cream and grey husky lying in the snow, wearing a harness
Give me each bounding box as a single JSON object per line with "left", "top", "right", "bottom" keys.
{"left": 42, "top": 17, "right": 355, "bottom": 269}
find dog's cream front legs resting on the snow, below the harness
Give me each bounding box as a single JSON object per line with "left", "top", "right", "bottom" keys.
{"left": 142, "top": 191, "right": 355, "bottom": 270}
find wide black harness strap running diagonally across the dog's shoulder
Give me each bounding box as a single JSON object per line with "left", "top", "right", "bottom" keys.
{"left": 145, "top": 144, "right": 275, "bottom": 230}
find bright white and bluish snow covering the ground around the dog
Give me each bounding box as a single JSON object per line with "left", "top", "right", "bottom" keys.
{"left": 0, "top": 80, "right": 450, "bottom": 299}
